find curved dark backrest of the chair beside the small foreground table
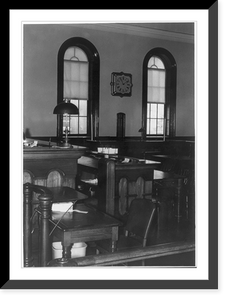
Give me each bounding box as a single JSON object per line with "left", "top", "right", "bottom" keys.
{"left": 125, "top": 198, "right": 156, "bottom": 243}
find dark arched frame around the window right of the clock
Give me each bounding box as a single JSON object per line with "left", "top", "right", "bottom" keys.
{"left": 142, "top": 48, "right": 177, "bottom": 139}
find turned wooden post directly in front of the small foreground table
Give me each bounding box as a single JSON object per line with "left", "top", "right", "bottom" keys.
{"left": 38, "top": 194, "right": 52, "bottom": 267}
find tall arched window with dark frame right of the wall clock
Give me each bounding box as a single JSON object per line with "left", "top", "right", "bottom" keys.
{"left": 142, "top": 48, "right": 176, "bottom": 137}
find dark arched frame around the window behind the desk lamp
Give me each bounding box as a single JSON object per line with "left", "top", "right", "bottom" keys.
{"left": 57, "top": 37, "right": 100, "bottom": 139}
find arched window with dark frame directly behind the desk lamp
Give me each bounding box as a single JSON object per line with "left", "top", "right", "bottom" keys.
{"left": 57, "top": 37, "right": 99, "bottom": 138}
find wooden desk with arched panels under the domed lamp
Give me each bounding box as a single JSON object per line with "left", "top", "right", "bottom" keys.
{"left": 23, "top": 140, "right": 87, "bottom": 188}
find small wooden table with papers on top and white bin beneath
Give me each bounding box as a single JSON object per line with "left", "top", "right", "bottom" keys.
{"left": 50, "top": 204, "right": 122, "bottom": 264}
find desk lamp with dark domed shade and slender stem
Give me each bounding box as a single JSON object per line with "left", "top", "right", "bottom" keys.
{"left": 53, "top": 99, "right": 79, "bottom": 148}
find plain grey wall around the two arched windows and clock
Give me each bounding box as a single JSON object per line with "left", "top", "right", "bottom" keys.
{"left": 23, "top": 24, "right": 195, "bottom": 136}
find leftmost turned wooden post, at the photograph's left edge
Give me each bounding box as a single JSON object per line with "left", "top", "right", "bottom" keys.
{"left": 23, "top": 183, "right": 34, "bottom": 267}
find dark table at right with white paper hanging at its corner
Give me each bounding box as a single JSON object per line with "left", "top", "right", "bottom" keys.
{"left": 153, "top": 170, "right": 185, "bottom": 222}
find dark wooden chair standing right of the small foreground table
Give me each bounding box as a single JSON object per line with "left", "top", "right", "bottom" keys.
{"left": 96, "top": 198, "right": 159, "bottom": 265}
